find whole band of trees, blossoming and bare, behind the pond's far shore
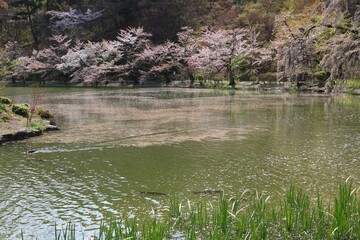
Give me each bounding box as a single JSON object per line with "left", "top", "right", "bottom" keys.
{"left": 0, "top": 0, "right": 360, "bottom": 92}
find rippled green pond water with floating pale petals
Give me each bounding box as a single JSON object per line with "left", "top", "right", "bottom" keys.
{"left": 0, "top": 88, "right": 360, "bottom": 239}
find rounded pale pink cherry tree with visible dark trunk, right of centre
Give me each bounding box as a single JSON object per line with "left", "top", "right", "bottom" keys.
{"left": 187, "top": 27, "right": 268, "bottom": 87}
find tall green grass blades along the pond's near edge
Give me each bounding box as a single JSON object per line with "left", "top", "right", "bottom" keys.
{"left": 22, "top": 181, "right": 360, "bottom": 240}
